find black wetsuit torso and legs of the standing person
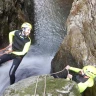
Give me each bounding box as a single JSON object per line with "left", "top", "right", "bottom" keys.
{"left": 0, "top": 30, "right": 31, "bottom": 84}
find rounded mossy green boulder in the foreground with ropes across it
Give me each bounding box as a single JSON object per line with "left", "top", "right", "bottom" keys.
{"left": 3, "top": 75, "right": 81, "bottom": 96}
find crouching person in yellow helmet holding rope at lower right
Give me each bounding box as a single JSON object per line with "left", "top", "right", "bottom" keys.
{"left": 64, "top": 65, "right": 96, "bottom": 93}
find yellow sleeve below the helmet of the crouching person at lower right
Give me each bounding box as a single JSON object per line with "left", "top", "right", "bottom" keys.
{"left": 78, "top": 78, "right": 94, "bottom": 93}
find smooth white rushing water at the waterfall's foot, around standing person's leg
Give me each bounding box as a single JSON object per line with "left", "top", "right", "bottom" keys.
{"left": 0, "top": 56, "right": 53, "bottom": 96}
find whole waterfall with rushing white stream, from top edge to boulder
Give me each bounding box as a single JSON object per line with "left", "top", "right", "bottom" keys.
{"left": 0, "top": 0, "right": 72, "bottom": 93}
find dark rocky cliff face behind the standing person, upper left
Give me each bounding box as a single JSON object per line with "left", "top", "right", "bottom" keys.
{"left": 0, "top": 0, "right": 33, "bottom": 47}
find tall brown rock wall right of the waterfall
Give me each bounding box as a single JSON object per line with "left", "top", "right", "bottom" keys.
{"left": 52, "top": 0, "right": 96, "bottom": 96}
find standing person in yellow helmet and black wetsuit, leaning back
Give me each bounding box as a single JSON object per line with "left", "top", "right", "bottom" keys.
{"left": 0, "top": 22, "right": 32, "bottom": 84}
